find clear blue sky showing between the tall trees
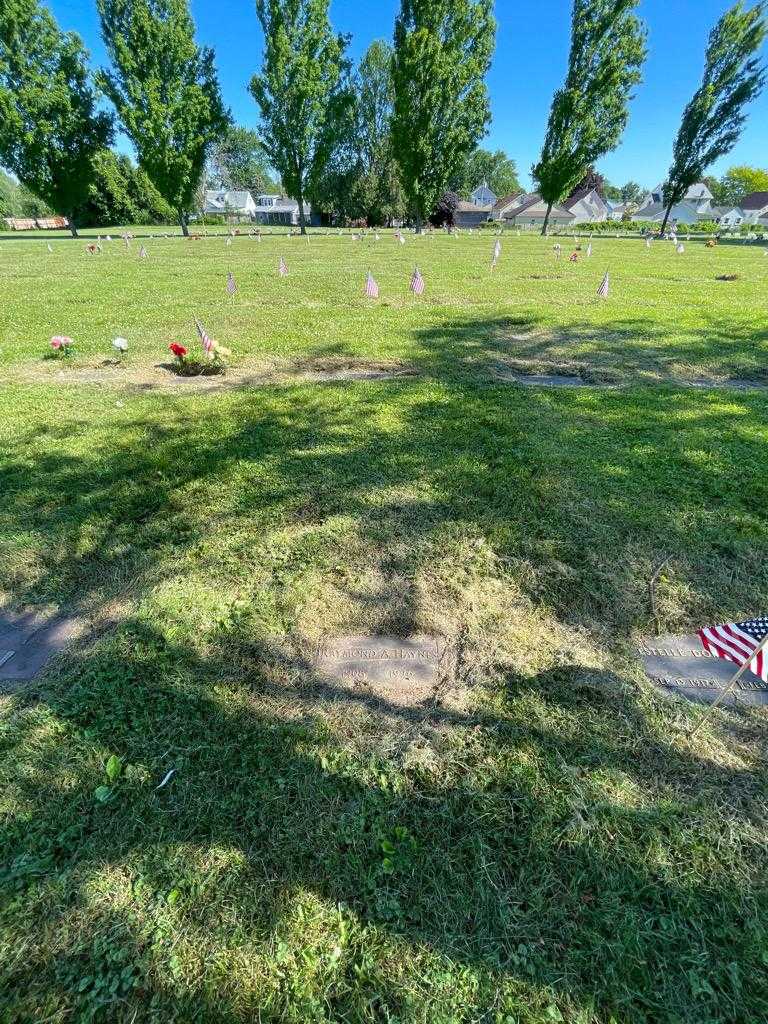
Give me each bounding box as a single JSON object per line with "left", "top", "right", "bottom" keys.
{"left": 49, "top": 0, "right": 768, "bottom": 187}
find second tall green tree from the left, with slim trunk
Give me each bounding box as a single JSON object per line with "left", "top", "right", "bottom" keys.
{"left": 97, "top": 0, "right": 229, "bottom": 234}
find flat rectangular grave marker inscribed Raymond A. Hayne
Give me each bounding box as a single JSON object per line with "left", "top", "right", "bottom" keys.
{"left": 312, "top": 636, "right": 441, "bottom": 707}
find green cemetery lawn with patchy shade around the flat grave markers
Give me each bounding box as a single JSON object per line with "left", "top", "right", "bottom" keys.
{"left": 0, "top": 229, "right": 768, "bottom": 1024}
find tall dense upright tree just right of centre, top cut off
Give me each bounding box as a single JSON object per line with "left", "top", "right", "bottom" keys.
{"left": 392, "top": 0, "right": 496, "bottom": 226}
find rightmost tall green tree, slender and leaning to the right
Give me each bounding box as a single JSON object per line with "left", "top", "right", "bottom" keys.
{"left": 662, "top": 0, "right": 768, "bottom": 231}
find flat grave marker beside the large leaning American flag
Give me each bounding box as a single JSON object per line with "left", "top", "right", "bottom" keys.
{"left": 639, "top": 635, "right": 768, "bottom": 707}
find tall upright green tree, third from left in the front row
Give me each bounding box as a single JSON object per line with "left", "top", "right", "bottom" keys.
{"left": 250, "top": 0, "right": 353, "bottom": 234}
